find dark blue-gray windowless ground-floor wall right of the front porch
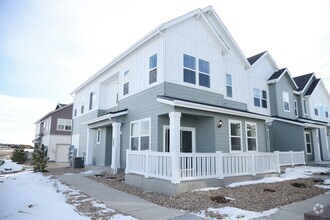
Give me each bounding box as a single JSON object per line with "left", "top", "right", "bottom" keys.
{"left": 269, "top": 121, "right": 305, "bottom": 151}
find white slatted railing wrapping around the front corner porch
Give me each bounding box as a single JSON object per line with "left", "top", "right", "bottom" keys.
{"left": 126, "top": 150, "right": 305, "bottom": 183}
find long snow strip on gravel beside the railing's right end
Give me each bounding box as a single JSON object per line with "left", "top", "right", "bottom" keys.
{"left": 228, "top": 166, "right": 330, "bottom": 187}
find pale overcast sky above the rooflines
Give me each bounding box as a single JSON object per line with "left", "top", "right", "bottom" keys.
{"left": 0, "top": 0, "right": 330, "bottom": 144}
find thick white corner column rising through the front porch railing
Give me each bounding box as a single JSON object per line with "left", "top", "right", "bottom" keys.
{"left": 169, "top": 112, "right": 181, "bottom": 183}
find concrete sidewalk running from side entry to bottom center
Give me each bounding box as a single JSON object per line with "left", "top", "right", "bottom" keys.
{"left": 58, "top": 174, "right": 203, "bottom": 220}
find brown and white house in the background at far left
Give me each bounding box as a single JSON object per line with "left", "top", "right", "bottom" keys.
{"left": 33, "top": 104, "right": 73, "bottom": 162}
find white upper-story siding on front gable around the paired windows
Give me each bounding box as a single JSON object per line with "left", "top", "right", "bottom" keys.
{"left": 165, "top": 17, "right": 246, "bottom": 105}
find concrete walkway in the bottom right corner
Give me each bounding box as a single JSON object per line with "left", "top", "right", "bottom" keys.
{"left": 258, "top": 192, "right": 330, "bottom": 220}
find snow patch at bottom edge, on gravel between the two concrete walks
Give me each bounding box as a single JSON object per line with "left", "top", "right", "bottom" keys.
{"left": 199, "top": 207, "right": 278, "bottom": 220}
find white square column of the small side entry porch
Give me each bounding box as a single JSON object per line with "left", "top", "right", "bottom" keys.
{"left": 111, "top": 122, "right": 121, "bottom": 173}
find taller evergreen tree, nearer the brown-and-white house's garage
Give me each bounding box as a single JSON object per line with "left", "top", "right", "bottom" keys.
{"left": 32, "top": 144, "right": 49, "bottom": 172}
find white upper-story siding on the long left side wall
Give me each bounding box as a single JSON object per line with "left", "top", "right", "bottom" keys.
{"left": 74, "top": 35, "right": 164, "bottom": 116}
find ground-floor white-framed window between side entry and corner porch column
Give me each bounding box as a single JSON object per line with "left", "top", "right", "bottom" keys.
{"left": 130, "top": 118, "right": 150, "bottom": 150}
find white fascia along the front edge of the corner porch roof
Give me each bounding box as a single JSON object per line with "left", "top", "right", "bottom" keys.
{"left": 157, "top": 98, "right": 271, "bottom": 121}
